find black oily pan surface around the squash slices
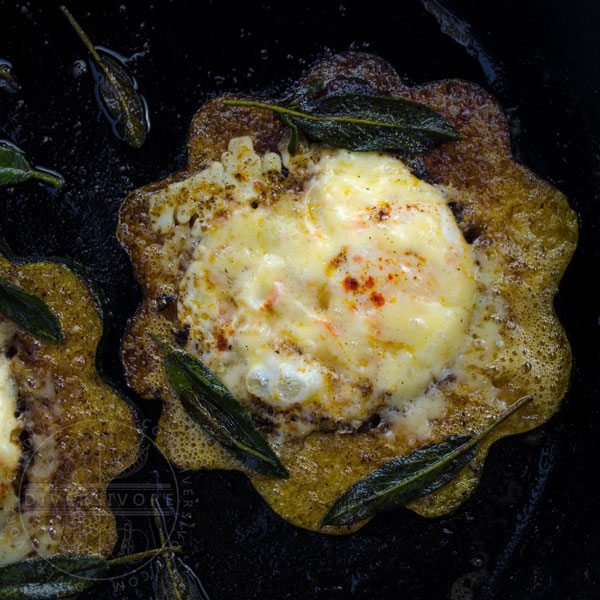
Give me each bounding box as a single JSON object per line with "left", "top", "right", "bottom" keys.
{"left": 0, "top": 0, "right": 600, "bottom": 600}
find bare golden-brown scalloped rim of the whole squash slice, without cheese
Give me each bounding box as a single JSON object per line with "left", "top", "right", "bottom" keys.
{"left": 118, "top": 53, "right": 577, "bottom": 534}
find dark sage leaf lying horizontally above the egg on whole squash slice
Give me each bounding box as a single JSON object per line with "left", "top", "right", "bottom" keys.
{"left": 223, "top": 94, "right": 464, "bottom": 154}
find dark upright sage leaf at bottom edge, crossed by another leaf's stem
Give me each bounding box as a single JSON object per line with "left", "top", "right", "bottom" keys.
{"left": 152, "top": 496, "right": 210, "bottom": 600}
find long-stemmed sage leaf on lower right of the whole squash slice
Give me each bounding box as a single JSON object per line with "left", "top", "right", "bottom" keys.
{"left": 319, "top": 396, "right": 532, "bottom": 527}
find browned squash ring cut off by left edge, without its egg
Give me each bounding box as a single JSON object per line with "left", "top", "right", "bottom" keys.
{"left": 0, "top": 254, "right": 141, "bottom": 558}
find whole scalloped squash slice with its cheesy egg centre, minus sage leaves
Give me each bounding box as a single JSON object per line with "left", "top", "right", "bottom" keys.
{"left": 118, "top": 53, "right": 577, "bottom": 533}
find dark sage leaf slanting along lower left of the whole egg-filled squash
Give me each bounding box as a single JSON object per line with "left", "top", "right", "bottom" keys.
{"left": 155, "top": 339, "right": 289, "bottom": 479}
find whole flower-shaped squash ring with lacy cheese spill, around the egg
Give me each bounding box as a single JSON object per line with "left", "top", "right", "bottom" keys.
{"left": 118, "top": 53, "right": 577, "bottom": 533}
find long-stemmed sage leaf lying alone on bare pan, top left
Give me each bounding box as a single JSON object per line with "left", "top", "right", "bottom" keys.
{"left": 60, "top": 6, "right": 149, "bottom": 148}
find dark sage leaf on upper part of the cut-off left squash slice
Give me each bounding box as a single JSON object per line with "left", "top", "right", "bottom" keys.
{"left": 0, "top": 278, "right": 65, "bottom": 344}
